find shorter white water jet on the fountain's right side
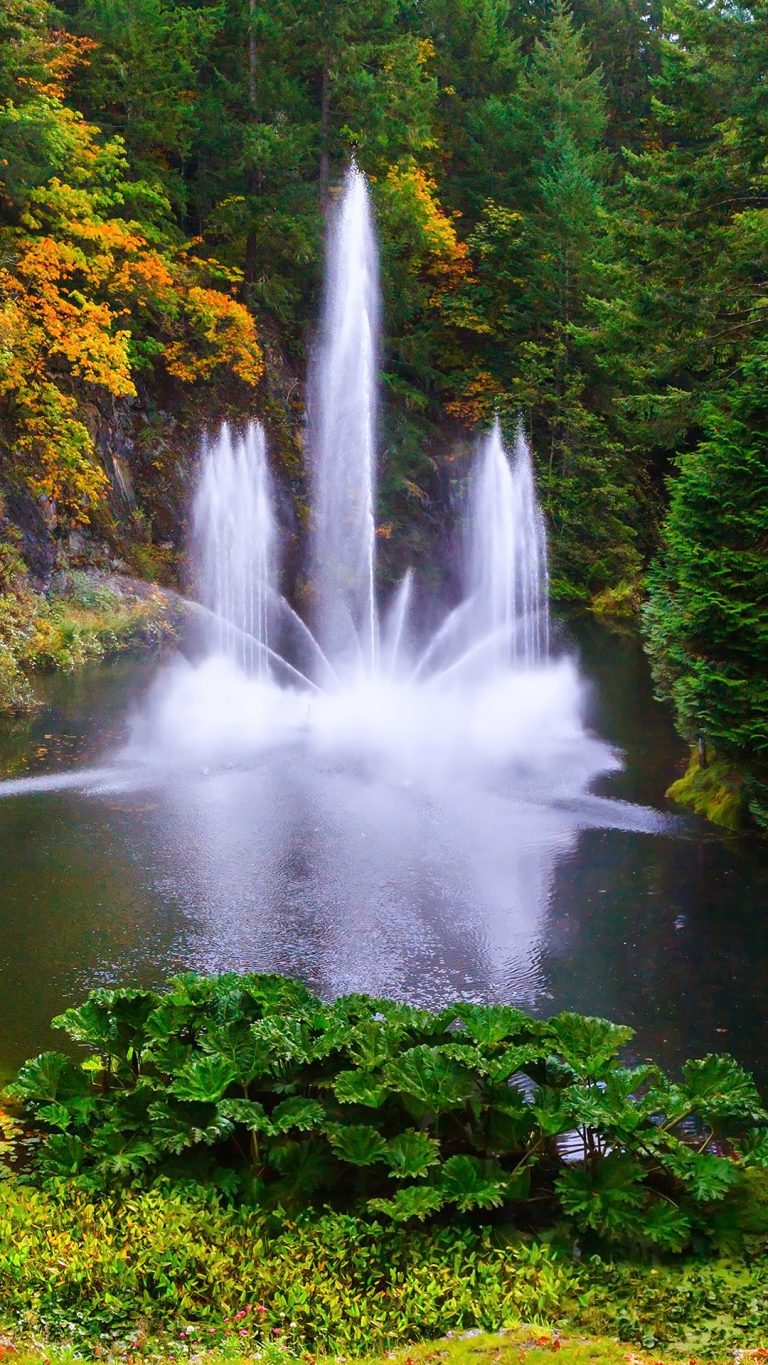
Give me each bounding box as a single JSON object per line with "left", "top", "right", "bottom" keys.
{"left": 467, "top": 418, "right": 550, "bottom": 669}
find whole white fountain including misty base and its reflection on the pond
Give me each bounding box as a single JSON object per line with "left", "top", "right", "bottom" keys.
{"left": 0, "top": 159, "right": 673, "bottom": 1026}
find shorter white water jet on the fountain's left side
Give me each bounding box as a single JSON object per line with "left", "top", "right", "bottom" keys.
{"left": 192, "top": 422, "right": 277, "bottom": 678}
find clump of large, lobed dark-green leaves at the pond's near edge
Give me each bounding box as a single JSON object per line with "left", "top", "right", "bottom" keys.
{"left": 11, "top": 973, "right": 768, "bottom": 1253}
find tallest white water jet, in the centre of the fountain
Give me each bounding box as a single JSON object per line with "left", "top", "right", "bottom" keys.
{"left": 310, "top": 165, "right": 379, "bottom": 672}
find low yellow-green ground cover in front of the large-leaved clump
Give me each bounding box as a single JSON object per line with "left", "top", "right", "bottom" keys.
{"left": 0, "top": 1179, "right": 768, "bottom": 1361}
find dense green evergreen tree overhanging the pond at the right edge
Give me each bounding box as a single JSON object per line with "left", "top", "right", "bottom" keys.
{"left": 647, "top": 341, "right": 768, "bottom": 827}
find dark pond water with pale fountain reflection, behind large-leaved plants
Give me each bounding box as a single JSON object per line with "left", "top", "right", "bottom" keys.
{"left": 0, "top": 622, "right": 768, "bottom": 1085}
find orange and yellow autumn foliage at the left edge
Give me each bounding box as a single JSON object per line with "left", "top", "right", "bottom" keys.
{"left": 0, "top": 10, "right": 262, "bottom": 520}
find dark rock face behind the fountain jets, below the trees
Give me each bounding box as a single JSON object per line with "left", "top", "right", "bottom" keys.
{"left": 0, "top": 336, "right": 463, "bottom": 597}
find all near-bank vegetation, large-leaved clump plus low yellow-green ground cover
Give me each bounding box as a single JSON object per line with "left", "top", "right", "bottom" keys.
{"left": 0, "top": 973, "right": 768, "bottom": 1365}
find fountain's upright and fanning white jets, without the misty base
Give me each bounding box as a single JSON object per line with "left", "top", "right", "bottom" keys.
{"left": 189, "top": 165, "right": 550, "bottom": 704}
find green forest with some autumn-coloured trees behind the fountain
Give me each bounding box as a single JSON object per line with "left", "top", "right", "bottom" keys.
{"left": 0, "top": 0, "right": 768, "bottom": 826}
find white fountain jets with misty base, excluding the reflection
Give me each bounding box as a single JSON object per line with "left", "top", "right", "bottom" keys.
{"left": 105, "top": 158, "right": 615, "bottom": 819}
